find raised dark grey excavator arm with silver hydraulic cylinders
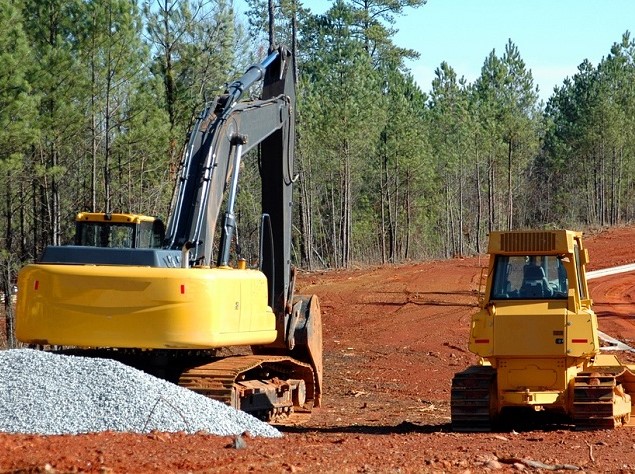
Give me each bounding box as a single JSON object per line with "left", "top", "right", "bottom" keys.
{"left": 165, "top": 48, "right": 295, "bottom": 314}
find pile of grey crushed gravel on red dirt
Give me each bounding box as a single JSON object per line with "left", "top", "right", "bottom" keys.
{"left": 0, "top": 349, "right": 281, "bottom": 437}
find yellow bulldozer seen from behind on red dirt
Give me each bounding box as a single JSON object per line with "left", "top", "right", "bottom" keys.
{"left": 451, "top": 230, "right": 635, "bottom": 431}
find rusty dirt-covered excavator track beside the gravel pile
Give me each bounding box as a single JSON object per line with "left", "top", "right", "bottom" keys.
{"left": 178, "top": 355, "right": 315, "bottom": 425}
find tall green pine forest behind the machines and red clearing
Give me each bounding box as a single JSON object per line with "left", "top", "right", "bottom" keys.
{"left": 0, "top": 0, "right": 635, "bottom": 288}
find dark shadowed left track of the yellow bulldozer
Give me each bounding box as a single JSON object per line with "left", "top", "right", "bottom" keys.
{"left": 450, "top": 365, "right": 496, "bottom": 432}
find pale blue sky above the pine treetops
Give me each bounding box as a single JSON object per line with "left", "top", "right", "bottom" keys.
{"left": 236, "top": 0, "right": 635, "bottom": 100}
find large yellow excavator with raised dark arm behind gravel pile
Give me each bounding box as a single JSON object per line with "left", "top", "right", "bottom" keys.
{"left": 16, "top": 47, "right": 322, "bottom": 424}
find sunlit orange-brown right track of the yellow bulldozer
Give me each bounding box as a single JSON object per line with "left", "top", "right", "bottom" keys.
{"left": 571, "top": 368, "right": 632, "bottom": 430}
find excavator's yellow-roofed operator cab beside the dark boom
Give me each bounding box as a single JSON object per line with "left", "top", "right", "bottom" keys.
{"left": 75, "top": 212, "right": 165, "bottom": 248}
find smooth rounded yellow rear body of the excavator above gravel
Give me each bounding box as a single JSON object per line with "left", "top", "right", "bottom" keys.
{"left": 16, "top": 264, "right": 277, "bottom": 349}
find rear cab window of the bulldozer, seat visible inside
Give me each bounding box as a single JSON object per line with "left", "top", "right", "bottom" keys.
{"left": 490, "top": 255, "right": 568, "bottom": 299}
